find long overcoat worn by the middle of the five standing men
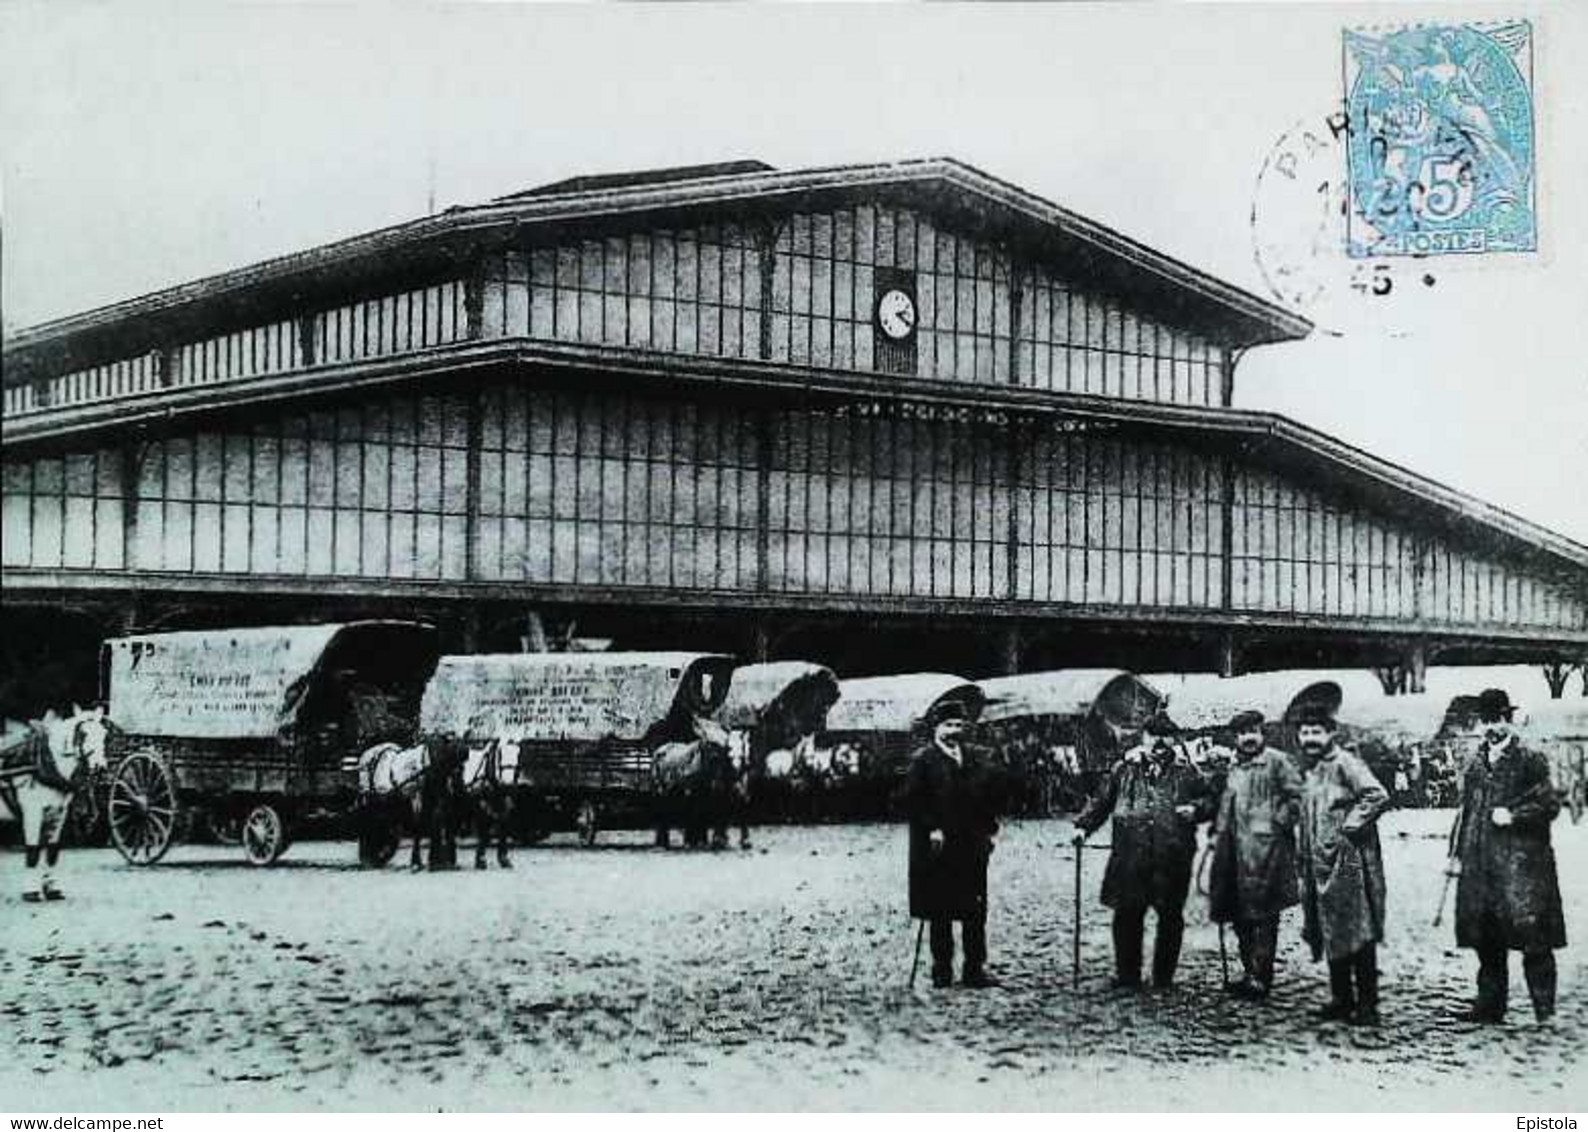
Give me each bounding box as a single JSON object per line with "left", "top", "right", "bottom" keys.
{"left": 1208, "top": 746, "right": 1302, "bottom": 924}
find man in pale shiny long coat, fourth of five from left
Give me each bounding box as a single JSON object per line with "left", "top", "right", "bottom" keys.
{"left": 1296, "top": 705, "right": 1390, "bottom": 1026}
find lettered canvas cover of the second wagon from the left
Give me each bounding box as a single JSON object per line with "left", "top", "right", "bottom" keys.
{"left": 419, "top": 653, "right": 734, "bottom": 743}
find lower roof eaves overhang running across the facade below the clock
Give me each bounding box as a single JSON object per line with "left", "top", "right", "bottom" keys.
{"left": 0, "top": 338, "right": 1588, "bottom": 577}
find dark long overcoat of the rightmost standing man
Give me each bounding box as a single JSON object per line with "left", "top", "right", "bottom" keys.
{"left": 1451, "top": 737, "right": 1566, "bottom": 951}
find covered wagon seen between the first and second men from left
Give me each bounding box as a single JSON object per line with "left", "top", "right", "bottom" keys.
{"left": 977, "top": 668, "right": 1164, "bottom": 816}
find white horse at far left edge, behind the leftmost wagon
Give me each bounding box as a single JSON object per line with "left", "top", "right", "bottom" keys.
{"left": 0, "top": 705, "right": 110, "bottom": 903}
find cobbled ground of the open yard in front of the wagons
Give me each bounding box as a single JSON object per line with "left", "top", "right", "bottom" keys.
{"left": 0, "top": 811, "right": 1588, "bottom": 1113}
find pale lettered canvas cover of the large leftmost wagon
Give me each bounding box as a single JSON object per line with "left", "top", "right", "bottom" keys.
{"left": 105, "top": 621, "right": 434, "bottom": 738}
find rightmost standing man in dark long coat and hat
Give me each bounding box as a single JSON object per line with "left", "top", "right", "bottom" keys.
{"left": 1450, "top": 687, "right": 1566, "bottom": 1022}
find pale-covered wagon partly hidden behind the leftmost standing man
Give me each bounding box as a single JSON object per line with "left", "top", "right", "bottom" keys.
{"left": 818, "top": 672, "right": 986, "bottom": 818}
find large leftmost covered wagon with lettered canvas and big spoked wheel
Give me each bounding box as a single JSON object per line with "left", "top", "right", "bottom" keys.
{"left": 102, "top": 621, "right": 440, "bottom": 865}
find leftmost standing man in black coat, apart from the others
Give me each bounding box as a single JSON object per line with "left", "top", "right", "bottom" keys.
{"left": 905, "top": 702, "right": 1002, "bottom": 988}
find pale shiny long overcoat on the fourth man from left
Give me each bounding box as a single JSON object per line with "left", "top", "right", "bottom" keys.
{"left": 1301, "top": 746, "right": 1390, "bottom": 959}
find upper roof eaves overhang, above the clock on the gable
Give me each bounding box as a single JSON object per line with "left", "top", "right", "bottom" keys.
{"left": 5, "top": 157, "right": 1312, "bottom": 384}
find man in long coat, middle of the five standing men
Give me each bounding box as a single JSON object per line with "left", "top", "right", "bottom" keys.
{"left": 1208, "top": 711, "right": 1302, "bottom": 999}
